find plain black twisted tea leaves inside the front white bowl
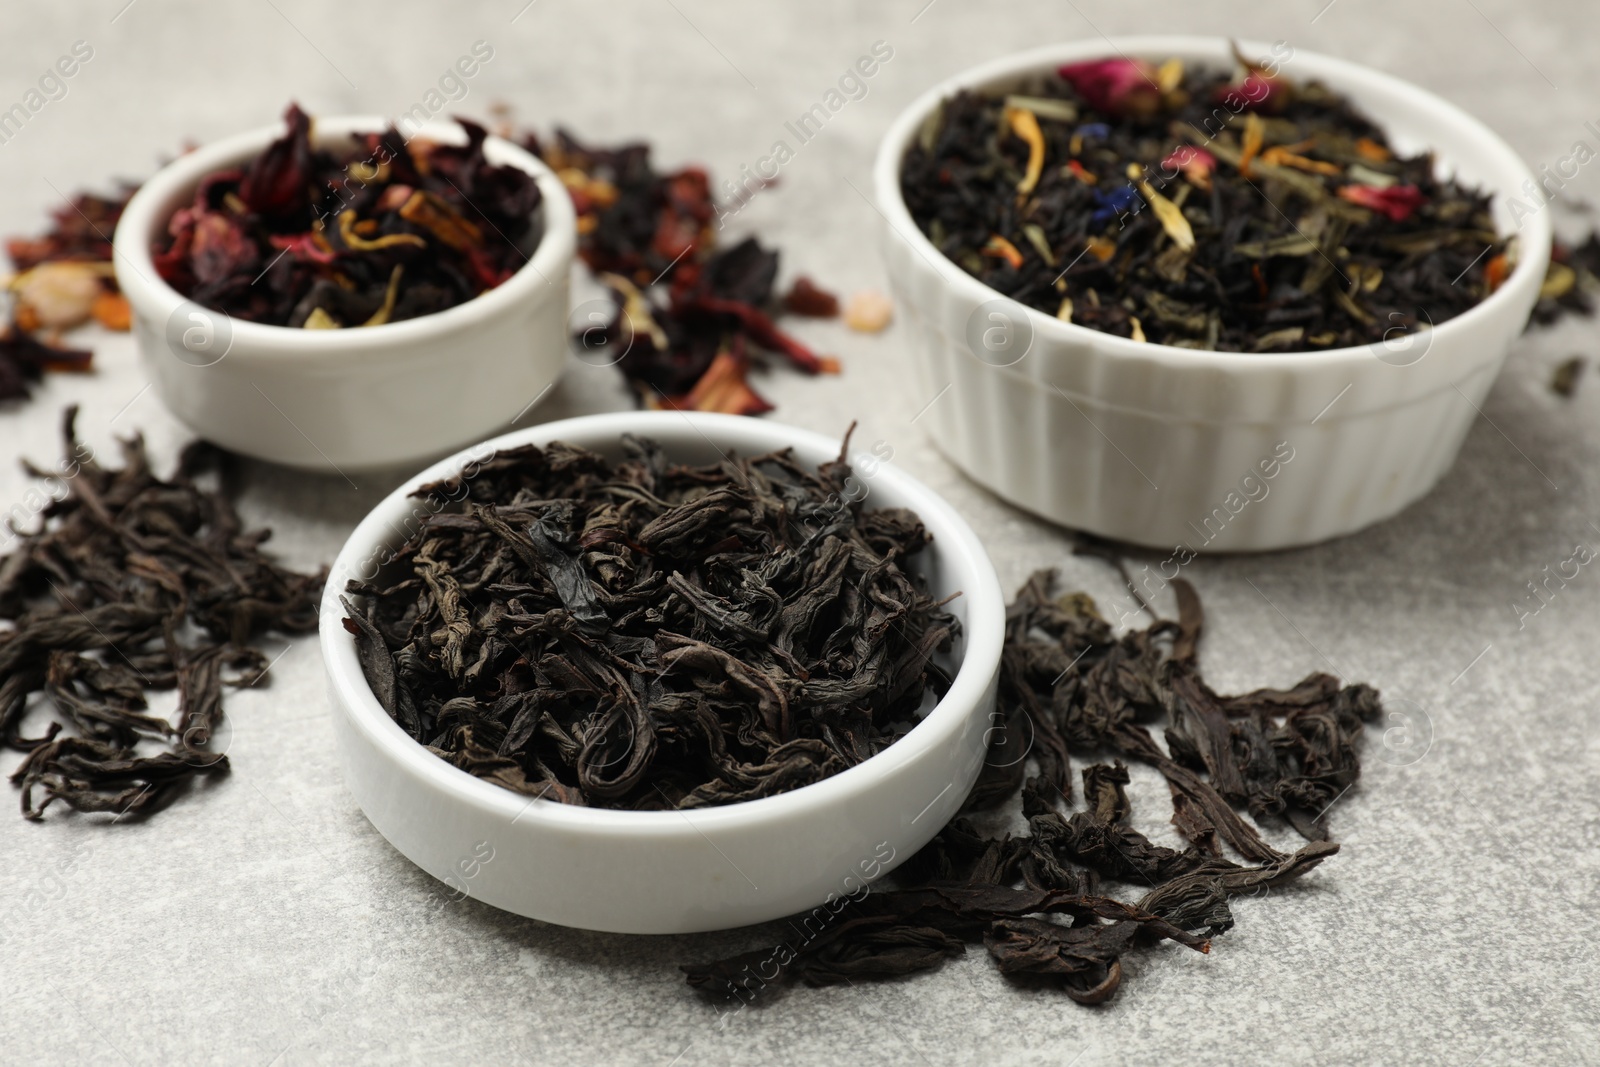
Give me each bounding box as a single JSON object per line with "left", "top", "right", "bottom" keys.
{"left": 346, "top": 438, "right": 958, "bottom": 809}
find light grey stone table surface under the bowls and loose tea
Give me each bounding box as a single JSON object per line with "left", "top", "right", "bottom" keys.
{"left": 0, "top": 0, "right": 1600, "bottom": 1067}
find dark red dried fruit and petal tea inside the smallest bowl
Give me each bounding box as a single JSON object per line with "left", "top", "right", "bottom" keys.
{"left": 152, "top": 104, "right": 539, "bottom": 330}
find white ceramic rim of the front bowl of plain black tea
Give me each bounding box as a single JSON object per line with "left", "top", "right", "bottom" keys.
{"left": 318, "top": 411, "right": 1005, "bottom": 838}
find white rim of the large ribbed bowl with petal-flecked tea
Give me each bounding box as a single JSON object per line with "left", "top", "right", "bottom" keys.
{"left": 874, "top": 35, "right": 1552, "bottom": 371}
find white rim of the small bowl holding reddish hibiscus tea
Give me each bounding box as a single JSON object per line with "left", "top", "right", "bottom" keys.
{"left": 114, "top": 115, "right": 578, "bottom": 358}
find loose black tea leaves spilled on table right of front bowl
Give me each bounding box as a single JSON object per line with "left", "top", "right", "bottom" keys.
{"left": 683, "top": 571, "right": 1382, "bottom": 1006}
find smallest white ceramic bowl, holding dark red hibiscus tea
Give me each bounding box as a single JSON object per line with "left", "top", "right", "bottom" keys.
{"left": 115, "top": 117, "right": 578, "bottom": 472}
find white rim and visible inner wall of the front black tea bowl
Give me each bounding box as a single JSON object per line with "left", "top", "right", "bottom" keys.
{"left": 322, "top": 413, "right": 1005, "bottom": 830}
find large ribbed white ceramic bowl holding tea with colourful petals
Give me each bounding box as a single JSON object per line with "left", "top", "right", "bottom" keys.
{"left": 874, "top": 37, "right": 1550, "bottom": 550}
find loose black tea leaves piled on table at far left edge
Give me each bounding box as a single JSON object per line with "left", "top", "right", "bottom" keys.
{"left": 0, "top": 408, "right": 323, "bottom": 819}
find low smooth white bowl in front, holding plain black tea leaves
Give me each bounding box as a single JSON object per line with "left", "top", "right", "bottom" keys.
{"left": 322, "top": 411, "right": 1005, "bottom": 934}
